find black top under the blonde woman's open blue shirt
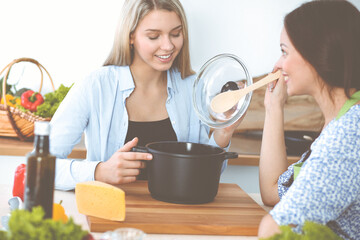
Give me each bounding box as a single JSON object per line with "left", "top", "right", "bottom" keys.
{"left": 125, "top": 118, "right": 177, "bottom": 180}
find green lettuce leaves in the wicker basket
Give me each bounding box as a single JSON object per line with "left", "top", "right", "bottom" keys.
{"left": 35, "top": 84, "right": 72, "bottom": 118}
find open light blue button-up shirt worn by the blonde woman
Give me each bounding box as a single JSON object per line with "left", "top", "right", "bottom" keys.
{"left": 50, "top": 66, "right": 227, "bottom": 190}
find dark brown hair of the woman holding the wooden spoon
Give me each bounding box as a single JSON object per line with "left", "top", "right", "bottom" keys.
{"left": 284, "top": 0, "right": 360, "bottom": 98}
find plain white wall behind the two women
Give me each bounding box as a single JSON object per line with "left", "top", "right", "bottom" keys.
{"left": 0, "top": 0, "right": 360, "bottom": 92}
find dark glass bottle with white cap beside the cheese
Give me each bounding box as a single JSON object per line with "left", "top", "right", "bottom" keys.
{"left": 25, "top": 121, "right": 56, "bottom": 218}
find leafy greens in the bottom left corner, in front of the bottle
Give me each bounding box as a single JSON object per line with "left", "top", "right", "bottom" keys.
{"left": 0, "top": 207, "right": 88, "bottom": 240}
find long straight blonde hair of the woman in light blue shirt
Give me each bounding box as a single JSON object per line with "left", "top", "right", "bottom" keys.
{"left": 104, "top": 0, "right": 194, "bottom": 78}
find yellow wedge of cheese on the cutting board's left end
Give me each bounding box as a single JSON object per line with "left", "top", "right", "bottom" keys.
{"left": 75, "top": 181, "right": 125, "bottom": 221}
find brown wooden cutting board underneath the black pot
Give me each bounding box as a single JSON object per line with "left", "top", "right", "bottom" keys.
{"left": 87, "top": 181, "right": 267, "bottom": 236}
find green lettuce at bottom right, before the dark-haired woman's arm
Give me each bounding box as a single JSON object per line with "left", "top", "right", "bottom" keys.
{"left": 264, "top": 221, "right": 342, "bottom": 240}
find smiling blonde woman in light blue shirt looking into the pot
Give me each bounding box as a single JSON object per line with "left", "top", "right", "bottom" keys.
{"left": 51, "top": 0, "right": 241, "bottom": 190}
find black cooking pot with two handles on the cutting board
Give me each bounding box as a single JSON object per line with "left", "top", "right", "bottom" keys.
{"left": 133, "top": 141, "right": 238, "bottom": 204}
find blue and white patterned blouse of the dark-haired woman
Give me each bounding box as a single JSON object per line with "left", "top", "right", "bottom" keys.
{"left": 270, "top": 105, "right": 360, "bottom": 239}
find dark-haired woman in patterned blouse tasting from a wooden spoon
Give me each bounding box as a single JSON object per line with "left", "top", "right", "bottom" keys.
{"left": 259, "top": 0, "right": 360, "bottom": 239}
